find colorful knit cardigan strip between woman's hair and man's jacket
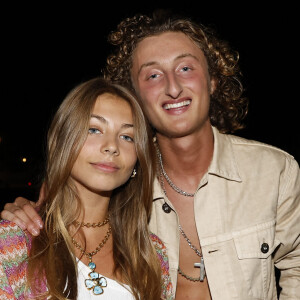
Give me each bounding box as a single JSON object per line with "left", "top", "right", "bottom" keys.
{"left": 150, "top": 233, "right": 174, "bottom": 300}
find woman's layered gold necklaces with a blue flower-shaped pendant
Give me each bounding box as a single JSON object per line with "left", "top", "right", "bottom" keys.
{"left": 72, "top": 217, "right": 111, "bottom": 295}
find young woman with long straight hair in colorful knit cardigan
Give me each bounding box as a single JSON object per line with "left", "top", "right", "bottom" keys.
{"left": 0, "top": 78, "right": 171, "bottom": 300}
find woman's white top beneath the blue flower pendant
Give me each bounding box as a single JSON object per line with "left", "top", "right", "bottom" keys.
{"left": 77, "top": 259, "right": 135, "bottom": 300}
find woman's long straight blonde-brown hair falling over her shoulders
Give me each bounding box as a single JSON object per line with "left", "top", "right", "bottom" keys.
{"left": 28, "top": 78, "right": 161, "bottom": 300}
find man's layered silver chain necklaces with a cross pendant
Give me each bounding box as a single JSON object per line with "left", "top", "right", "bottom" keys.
{"left": 156, "top": 144, "right": 206, "bottom": 282}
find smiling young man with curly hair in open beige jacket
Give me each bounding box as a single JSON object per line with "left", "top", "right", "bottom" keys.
{"left": 2, "top": 10, "right": 300, "bottom": 300}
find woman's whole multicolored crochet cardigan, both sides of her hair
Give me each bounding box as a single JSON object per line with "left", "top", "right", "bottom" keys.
{"left": 0, "top": 220, "right": 173, "bottom": 300}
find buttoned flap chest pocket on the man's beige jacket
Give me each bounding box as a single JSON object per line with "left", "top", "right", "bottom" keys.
{"left": 233, "top": 220, "right": 280, "bottom": 299}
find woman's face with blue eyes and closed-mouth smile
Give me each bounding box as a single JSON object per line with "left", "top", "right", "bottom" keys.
{"left": 71, "top": 93, "right": 137, "bottom": 193}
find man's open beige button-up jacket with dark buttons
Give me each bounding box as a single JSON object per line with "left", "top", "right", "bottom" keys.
{"left": 150, "top": 128, "right": 300, "bottom": 300}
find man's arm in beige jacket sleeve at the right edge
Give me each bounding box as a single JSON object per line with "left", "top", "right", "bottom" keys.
{"left": 274, "top": 159, "right": 300, "bottom": 299}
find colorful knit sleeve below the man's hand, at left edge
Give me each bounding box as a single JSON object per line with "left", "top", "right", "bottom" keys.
{"left": 0, "top": 220, "right": 31, "bottom": 300}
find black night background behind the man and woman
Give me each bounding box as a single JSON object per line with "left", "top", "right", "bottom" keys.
{"left": 0, "top": 1, "right": 300, "bottom": 209}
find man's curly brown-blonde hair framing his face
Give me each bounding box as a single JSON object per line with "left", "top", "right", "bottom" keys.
{"left": 104, "top": 10, "right": 248, "bottom": 133}
